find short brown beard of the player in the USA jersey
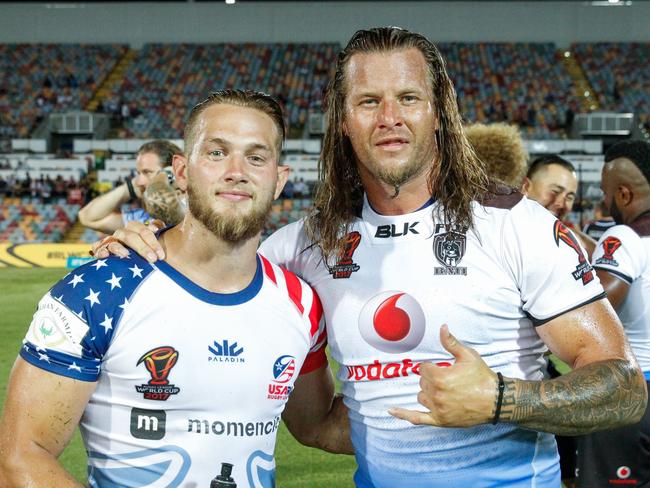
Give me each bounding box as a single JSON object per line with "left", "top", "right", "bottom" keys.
{"left": 187, "top": 185, "right": 272, "bottom": 244}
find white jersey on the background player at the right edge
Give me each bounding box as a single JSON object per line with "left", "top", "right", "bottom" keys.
{"left": 592, "top": 213, "right": 650, "bottom": 381}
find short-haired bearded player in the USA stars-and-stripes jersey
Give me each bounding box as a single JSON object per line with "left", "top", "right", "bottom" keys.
{"left": 0, "top": 90, "right": 349, "bottom": 487}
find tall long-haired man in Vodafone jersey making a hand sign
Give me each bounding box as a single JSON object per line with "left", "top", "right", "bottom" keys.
{"left": 90, "top": 28, "right": 647, "bottom": 488}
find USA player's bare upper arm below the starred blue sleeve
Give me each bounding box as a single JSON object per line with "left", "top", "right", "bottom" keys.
{"left": 0, "top": 358, "right": 96, "bottom": 488}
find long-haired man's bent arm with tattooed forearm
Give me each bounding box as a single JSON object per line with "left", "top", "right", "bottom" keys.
{"left": 501, "top": 300, "right": 647, "bottom": 435}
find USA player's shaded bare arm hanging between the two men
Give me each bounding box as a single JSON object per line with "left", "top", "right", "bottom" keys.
{"left": 282, "top": 365, "right": 354, "bottom": 454}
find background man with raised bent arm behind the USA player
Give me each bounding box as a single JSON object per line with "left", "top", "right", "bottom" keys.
{"left": 79, "top": 140, "right": 183, "bottom": 233}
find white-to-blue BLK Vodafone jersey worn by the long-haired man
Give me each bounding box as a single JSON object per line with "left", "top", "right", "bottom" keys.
{"left": 261, "top": 193, "right": 603, "bottom": 488}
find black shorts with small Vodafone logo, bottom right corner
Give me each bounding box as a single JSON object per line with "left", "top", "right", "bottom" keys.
{"left": 576, "top": 381, "right": 650, "bottom": 488}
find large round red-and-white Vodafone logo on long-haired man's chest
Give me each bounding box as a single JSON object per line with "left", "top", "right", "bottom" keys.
{"left": 359, "top": 291, "right": 425, "bottom": 353}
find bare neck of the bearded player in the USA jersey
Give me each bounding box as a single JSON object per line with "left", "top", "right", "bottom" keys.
{"left": 161, "top": 214, "right": 259, "bottom": 293}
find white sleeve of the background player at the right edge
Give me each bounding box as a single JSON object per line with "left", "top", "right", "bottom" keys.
{"left": 592, "top": 225, "right": 645, "bottom": 283}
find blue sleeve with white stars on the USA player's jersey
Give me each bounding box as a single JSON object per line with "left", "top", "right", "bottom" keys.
{"left": 20, "top": 253, "right": 152, "bottom": 382}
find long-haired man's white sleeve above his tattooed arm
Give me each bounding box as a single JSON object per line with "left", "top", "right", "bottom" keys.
{"left": 502, "top": 199, "right": 605, "bottom": 326}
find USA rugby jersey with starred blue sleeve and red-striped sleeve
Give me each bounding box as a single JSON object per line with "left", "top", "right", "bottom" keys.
{"left": 21, "top": 253, "right": 326, "bottom": 488}
